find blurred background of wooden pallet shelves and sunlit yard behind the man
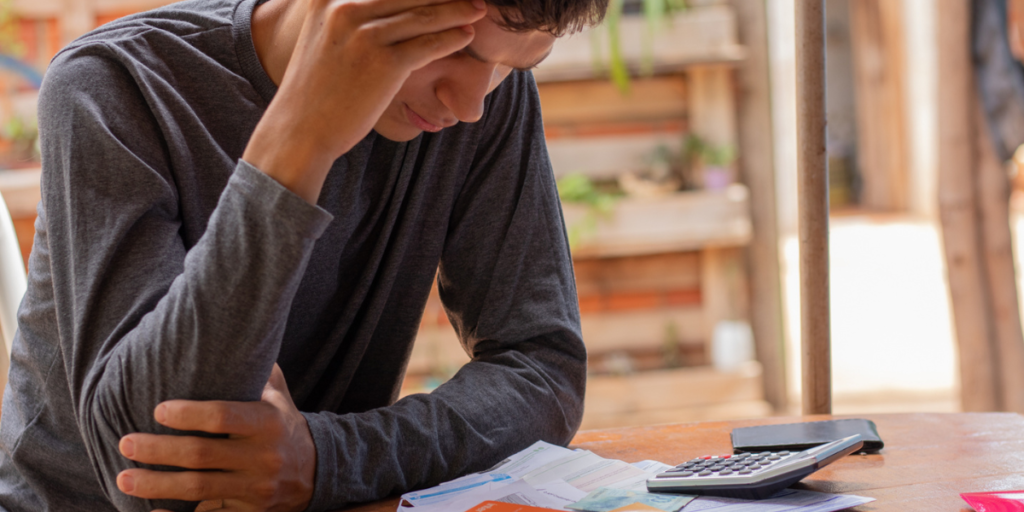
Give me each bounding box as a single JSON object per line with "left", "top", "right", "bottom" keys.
{"left": 0, "top": 0, "right": 1024, "bottom": 428}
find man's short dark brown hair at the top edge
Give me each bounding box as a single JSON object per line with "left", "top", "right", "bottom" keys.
{"left": 487, "top": 0, "right": 608, "bottom": 37}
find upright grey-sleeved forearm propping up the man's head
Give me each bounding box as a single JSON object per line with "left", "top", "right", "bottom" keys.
{"left": 73, "top": 158, "right": 330, "bottom": 510}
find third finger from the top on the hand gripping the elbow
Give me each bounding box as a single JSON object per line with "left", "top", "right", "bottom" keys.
{"left": 118, "top": 469, "right": 249, "bottom": 502}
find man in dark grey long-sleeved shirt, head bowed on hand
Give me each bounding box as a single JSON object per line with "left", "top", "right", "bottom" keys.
{"left": 0, "top": 0, "right": 605, "bottom": 512}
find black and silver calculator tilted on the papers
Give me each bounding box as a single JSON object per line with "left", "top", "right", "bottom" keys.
{"left": 647, "top": 434, "right": 864, "bottom": 500}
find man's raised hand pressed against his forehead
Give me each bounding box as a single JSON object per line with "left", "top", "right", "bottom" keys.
{"left": 243, "top": 0, "right": 487, "bottom": 203}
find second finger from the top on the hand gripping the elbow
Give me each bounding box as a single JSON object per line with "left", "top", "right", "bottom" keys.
{"left": 118, "top": 434, "right": 255, "bottom": 469}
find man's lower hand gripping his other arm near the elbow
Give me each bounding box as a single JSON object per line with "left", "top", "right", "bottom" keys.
{"left": 118, "top": 365, "right": 316, "bottom": 512}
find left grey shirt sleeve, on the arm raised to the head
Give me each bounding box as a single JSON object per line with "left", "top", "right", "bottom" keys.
{"left": 39, "top": 44, "right": 332, "bottom": 512}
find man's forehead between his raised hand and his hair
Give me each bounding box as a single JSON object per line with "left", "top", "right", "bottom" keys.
{"left": 469, "top": 5, "right": 555, "bottom": 68}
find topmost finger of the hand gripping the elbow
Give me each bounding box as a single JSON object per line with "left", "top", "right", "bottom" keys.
{"left": 154, "top": 400, "right": 273, "bottom": 436}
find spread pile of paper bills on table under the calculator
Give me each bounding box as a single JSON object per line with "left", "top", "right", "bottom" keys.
{"left": 397, "top": 441, "right": 872, "bottom": 512}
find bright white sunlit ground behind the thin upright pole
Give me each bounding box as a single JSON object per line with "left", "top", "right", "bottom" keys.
{"left": 782, "top": 215, "right": 962, "bottom": 414}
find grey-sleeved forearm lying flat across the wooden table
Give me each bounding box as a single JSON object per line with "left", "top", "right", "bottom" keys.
{"left": 306, "top": 333, "right": 586, "bottom": 510}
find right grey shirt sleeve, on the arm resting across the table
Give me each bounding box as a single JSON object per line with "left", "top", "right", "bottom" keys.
{"left": 306, "top": 72, "right": 587, "bottom": 511}
